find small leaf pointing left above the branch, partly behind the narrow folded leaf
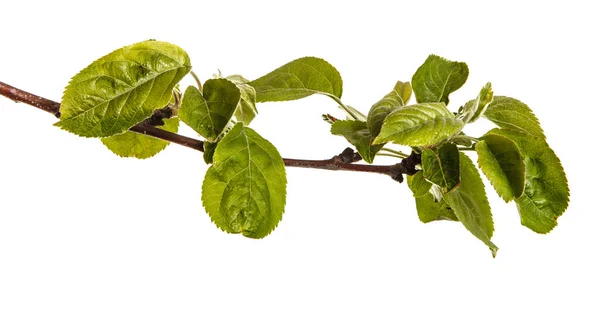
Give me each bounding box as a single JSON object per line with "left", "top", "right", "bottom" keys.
{"left": 331, "top": 120, "right": 383, "bottom": 163}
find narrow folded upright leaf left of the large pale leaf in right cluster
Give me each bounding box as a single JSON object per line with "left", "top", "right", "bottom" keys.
{"left": 367, "top": 81, "right": 412, "bottom": 136}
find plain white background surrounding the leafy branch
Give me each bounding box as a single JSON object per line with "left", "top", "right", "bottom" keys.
{"left": 0, "top": 0, "right": 600, "bottom": 311}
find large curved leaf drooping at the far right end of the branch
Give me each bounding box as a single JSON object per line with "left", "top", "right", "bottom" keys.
{"left": 488, "top": 129, "right": 569, "bottom": 233}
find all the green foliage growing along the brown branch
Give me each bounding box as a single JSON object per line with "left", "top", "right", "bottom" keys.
{"left": 56, "top": 41, "right": 569, "bottom": 255}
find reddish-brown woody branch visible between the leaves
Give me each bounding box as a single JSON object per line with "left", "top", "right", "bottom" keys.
{"left": 0, "top": 82, "right": 421, "bottom": 182}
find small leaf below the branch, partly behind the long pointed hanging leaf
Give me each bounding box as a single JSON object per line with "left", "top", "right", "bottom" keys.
{"left": 407, "top": 171, "right": 458, "bottom": 223}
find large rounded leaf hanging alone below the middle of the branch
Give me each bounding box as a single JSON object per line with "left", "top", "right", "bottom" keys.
{"left": 202, "top": 123, "right": 286, "bottom": 239}
